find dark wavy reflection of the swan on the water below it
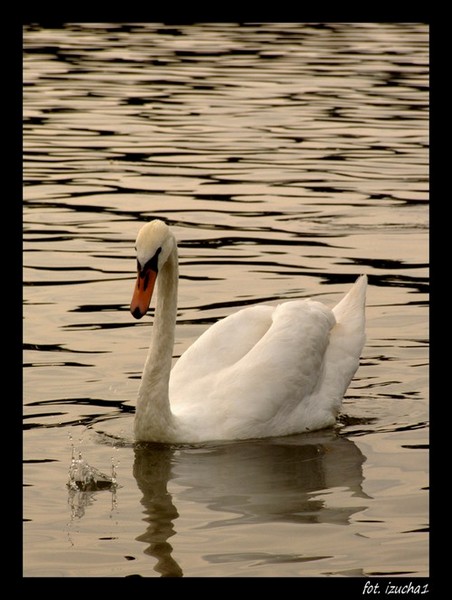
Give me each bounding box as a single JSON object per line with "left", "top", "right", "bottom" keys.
{"left": 133, "top": 431, "right": 369, "bottom": 577}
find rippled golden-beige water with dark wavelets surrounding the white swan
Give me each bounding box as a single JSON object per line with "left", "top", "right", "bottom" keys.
{"left": 23, "top": 23, "right": 429, "bottom": 578}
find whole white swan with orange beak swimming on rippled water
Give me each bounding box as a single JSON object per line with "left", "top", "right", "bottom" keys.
{"left": 130, "top": 220, "right": 367, "bottom": 443}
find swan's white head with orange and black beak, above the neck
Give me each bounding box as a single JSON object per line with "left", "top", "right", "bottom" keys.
{"left": 130, "top": 219, "right": 176, "bottom": 319}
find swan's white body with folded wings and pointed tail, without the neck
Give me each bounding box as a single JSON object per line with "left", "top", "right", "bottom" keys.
{"left": 169, "top": 277, "right": 366, "bottom": 441}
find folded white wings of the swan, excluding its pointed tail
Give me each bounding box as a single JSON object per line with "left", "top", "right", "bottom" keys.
{"left": 170, "top": 300, "right": 335, "bottom": 439}
